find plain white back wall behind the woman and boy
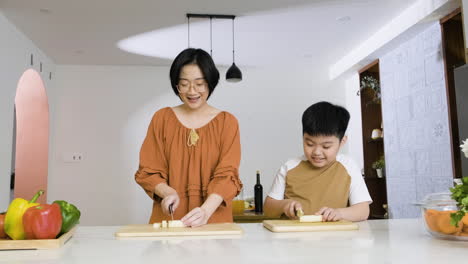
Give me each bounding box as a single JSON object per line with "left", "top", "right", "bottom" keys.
{"left": 49, "top": 66, "right": 345, "bottom": 225}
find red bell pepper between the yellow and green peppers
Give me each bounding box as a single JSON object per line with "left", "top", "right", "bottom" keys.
{"left": 23, "top": 204, "right": 62, "bottom": 239}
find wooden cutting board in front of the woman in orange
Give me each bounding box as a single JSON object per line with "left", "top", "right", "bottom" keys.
{"left": 115, "top": 223, "right": 243, "bottom": 237}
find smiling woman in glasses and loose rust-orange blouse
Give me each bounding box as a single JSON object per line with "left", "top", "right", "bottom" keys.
{"left": 135, "top": 48, "right": 242, "bottom": 227}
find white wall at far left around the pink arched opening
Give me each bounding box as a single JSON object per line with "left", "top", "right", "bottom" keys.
{"left": 0, "top": 11, "right": 55, "bottom": 212}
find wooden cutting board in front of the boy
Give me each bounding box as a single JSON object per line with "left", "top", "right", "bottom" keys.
{"left": 263, "top": 220, "right": 359, "bottom": 232}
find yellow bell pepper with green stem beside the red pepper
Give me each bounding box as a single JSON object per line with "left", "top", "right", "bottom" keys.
{"left": 4, "top": 190, "right": 44, "bottom": 240}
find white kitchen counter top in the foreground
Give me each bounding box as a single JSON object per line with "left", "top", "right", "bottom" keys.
{"left": 0, "top": 219, "right": 468, "bottom": 264}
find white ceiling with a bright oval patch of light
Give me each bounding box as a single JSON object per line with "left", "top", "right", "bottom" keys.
{"left": 0, "top": 0, "right": 416, "bottom": 68}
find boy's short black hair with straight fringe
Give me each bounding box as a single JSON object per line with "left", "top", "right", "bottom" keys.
{"left": 302, "top": 102, "right": 350, "bottom": 141}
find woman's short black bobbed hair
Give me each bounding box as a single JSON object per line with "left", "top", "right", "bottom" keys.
{"left": 169, "top": 48, "right": 219, "bottom": 98}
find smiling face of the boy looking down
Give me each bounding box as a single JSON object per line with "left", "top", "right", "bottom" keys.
{"left": 303, "top": 133, "right": 346, "bottom": 168}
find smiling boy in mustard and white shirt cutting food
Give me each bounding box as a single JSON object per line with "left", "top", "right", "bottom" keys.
{"left": 264, "top": 102, "right": 372, "bottom": 221}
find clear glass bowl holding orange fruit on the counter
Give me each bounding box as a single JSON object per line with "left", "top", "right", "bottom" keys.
{"left": 420, "top": 192, "right": 468, "bottom": 241}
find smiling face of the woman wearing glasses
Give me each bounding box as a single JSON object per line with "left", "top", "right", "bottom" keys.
{"left": 177, "top": 64, "right": 209, "bottom": 110}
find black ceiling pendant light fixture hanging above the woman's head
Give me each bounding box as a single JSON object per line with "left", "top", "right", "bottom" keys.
{"left": 187, "top": 13, "right": 242, "bottom": 82}
